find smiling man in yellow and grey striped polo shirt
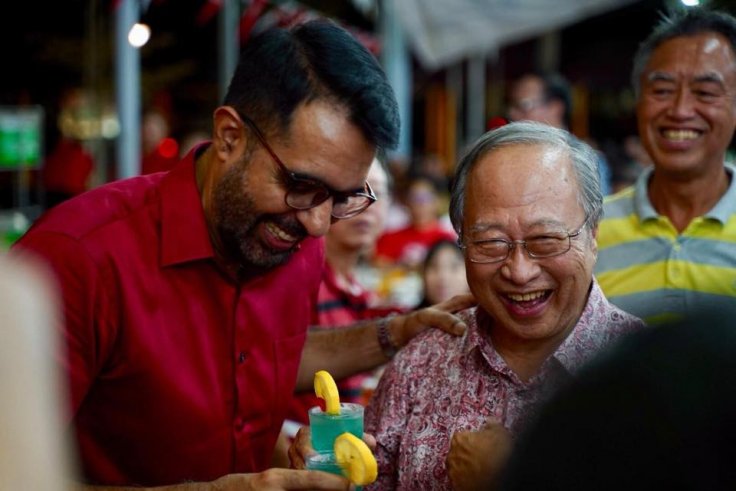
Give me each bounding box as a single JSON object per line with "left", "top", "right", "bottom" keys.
{"left": 595, "top": 9, "right": 736, "bottom": 324}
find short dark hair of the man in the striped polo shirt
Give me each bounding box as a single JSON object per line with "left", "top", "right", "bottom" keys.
{"left": 631, "top": 7, "right": 736, "bottom": 98}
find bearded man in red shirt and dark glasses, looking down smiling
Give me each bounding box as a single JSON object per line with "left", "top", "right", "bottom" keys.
{"left": 11, "top": 21, "right": 466, "bottom": 490}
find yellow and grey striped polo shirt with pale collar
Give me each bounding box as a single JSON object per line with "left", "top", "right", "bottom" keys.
{"left": 595, "top": 164, "right": 736, "bottom": 324}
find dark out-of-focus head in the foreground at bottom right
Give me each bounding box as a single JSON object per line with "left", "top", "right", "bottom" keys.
{"left": 501, "top": 308, "right": 736, "bottom": 490}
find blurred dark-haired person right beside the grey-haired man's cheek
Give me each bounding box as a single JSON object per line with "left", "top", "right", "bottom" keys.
{"left": 417, "top": 239, "right": 470, "bottom": 308}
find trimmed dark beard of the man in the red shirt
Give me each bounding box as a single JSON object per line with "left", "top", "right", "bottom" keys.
{"left": 213, "top": 151, "right": 307, "bottom": 276}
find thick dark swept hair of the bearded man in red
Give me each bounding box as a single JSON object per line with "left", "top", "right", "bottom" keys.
{"left": 224, "top": 19, "right": 399, "bottom": 150}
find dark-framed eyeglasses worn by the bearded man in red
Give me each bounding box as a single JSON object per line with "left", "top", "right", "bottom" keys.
{"left": 239, "top": 113, "right": 378, "bottom": 219}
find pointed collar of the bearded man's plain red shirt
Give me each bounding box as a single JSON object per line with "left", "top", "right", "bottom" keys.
{"left": 160, "top": 143, "right": 215, "bottom": 266}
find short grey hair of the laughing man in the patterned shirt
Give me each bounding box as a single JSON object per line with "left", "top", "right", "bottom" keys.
{"left": 450, "top": 121, "right": 603, "bottom": 240}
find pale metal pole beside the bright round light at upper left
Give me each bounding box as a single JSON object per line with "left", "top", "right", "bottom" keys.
{"left": 115, "top": 0, "right": 141, "bottom": 179}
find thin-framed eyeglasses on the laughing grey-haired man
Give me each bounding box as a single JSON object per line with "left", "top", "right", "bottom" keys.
{"left": 460, "top": 216, "right": 589, "bottom": 264}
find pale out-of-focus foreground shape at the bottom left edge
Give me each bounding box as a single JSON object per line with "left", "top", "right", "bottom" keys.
{"left": 0, "top": 254, "right": 72, "bottom": 491}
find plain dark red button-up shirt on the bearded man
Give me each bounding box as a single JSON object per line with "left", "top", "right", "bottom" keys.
{"left": 16, "top": 150, "right": 324, "bottom": 485}
